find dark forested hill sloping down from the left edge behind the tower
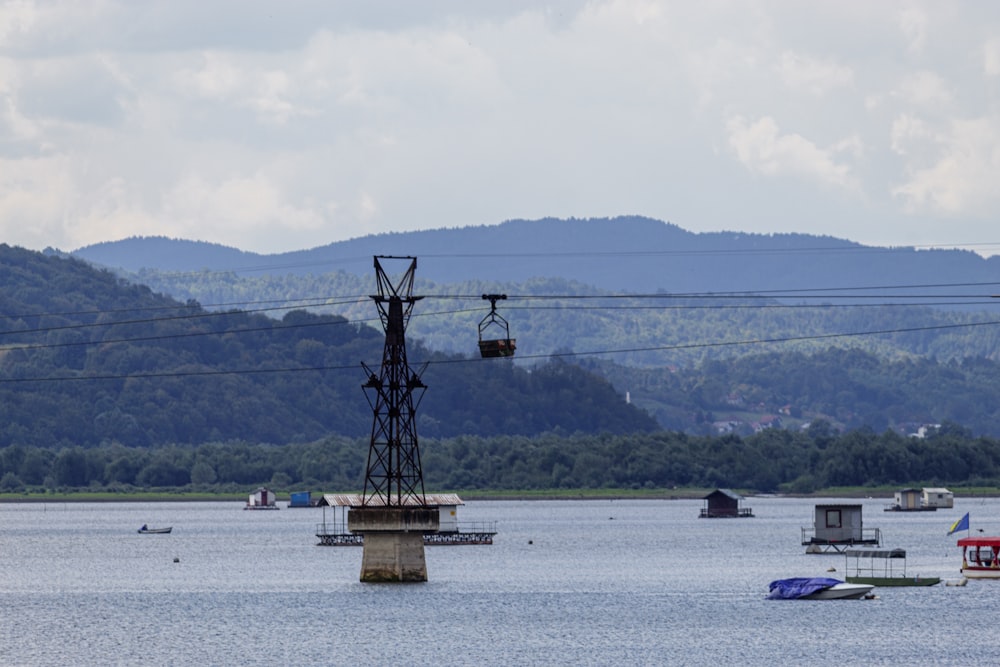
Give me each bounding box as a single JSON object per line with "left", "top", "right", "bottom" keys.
{"left": 0, "top": 245, "right": 656, "bottom": 447}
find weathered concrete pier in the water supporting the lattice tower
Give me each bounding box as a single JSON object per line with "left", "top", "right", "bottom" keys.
{"left": 347, "top": 507, "right": 440, "bottom": 583}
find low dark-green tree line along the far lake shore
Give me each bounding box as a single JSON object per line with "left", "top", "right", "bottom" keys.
{"left": 0, "top": 421, "right": 1000, "bottom": 493}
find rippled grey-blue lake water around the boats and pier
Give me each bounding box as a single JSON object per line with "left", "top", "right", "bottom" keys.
{"left": 0, "top": 497, "right": 1000, "bottom": 667}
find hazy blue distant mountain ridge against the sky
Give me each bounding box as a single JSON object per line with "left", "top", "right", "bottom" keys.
{"left": 68, "top": 216, "right": 1000, "bottom": 302}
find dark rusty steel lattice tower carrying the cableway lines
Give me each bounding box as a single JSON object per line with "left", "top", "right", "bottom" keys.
{"left": 361, "top": 256, "right": 426, "bottom": 507}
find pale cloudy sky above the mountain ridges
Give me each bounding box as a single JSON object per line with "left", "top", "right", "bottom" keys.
{"left": 0, "top": 0, "right": 1000, "bottom": 255}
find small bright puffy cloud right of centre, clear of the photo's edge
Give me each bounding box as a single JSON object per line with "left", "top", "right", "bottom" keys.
{"left": 726, "top": 116, "right": 860, "bottom": 190}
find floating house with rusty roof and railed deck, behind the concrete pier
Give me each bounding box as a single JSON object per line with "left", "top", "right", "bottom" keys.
{"left": 316, "top": 493, "right": 497, "bottom": 547}
